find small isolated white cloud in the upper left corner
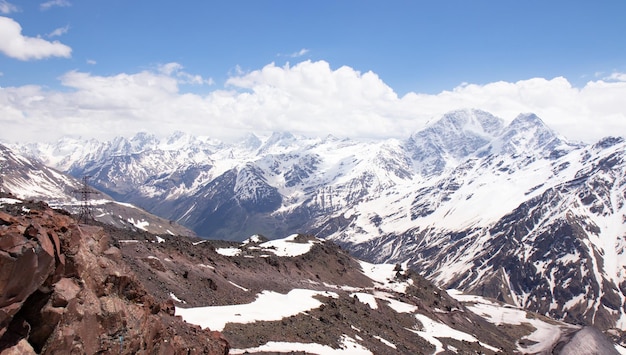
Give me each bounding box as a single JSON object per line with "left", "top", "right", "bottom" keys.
{"left": 0, "top": 16, "right": 72, "bottom": 60}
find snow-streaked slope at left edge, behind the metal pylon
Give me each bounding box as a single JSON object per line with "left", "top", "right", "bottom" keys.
{"left": 0, "top": 145, "right": 194, "bottom": 235}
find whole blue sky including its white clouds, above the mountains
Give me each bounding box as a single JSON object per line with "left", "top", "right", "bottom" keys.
{"left": 0, "top": 0, "right": 626, "bottom": 140}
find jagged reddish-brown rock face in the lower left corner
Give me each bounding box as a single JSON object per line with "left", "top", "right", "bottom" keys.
{"left": 0, "top": 200, "right": 229, "bottom": 354}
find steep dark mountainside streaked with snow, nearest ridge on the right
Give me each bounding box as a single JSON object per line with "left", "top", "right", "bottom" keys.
{"left": 327, "top": 139, "right": 626, "bottom": 329}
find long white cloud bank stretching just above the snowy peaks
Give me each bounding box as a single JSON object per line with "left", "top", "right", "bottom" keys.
{"left": 0, "top": 61, "right": 626, "bottom": 142}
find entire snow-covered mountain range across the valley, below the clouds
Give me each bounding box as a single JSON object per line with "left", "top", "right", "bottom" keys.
{"left": 9, "top": 110, "right": 626, "bottom": 329}
